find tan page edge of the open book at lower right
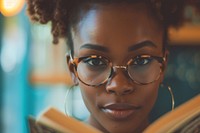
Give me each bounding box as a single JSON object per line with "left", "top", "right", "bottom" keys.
{"left": 144, "top": 95, "right": 200, "bottom": 133}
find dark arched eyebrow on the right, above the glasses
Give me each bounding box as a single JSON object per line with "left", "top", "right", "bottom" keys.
{"left": 128, "top": 40, "right": 157, "bottom": 52}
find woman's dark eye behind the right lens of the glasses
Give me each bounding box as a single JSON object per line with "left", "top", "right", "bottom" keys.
{"left": 133, "top": 57, "right": 152, "bottom": 66}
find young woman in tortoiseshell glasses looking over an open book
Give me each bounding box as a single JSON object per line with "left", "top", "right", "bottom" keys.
{"left": 28, "top": 0, "right": 198, "bottom": 133}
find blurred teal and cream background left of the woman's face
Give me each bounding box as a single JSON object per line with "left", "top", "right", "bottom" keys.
{"left": 0, "top": 9, "right": 88, "bottom": 133}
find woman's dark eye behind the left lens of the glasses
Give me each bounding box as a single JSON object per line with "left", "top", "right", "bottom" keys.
{"left": 83, "top": 58, "right": 107, "bottom": 67}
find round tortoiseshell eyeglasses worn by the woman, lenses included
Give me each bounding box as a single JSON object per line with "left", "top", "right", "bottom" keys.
{"left": 70, "top": 55, "right": 165, "bottom": 87}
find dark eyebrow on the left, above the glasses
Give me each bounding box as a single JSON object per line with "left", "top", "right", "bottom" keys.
{"left": 80, "top": 44, "right": 110, "bottom": 52}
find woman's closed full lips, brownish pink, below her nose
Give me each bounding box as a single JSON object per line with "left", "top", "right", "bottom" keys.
{"left": 101, "top": 103, "right": 141, "bottom": 120}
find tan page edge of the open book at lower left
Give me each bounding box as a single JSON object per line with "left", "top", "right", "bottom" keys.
{"left": 37, "top": 108, "right": 101, "bottom": 133}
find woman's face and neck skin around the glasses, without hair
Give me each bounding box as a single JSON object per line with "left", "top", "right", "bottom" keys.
{"left": 69, "top": 3, "right": 163, "bottom": 133}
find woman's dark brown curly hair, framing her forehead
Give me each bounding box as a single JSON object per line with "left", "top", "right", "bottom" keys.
{"left": 27, "top": 0, "right": 200, "bottom": 50}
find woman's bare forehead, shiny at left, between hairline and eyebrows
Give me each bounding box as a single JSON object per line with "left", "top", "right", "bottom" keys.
{"left": 73, "top": 3, "right": 162, "bottom": 56}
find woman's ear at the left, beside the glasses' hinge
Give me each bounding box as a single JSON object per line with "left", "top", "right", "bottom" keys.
{"left": 66, "top": 54, "right": 78, "bottom": 85}
